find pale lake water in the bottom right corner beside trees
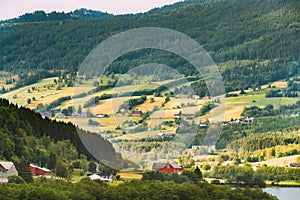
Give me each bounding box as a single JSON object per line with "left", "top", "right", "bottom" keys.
{"left": 263, "top": 187, "right": 300, "bottom": 200}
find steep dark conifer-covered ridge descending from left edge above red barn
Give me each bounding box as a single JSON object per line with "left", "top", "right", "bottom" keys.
{"left": 0, "top": 99, "right": 112, "bottom": 167}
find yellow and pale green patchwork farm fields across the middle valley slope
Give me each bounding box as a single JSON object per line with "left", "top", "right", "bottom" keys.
{"left": 1, "top": 77, "right": 299, "bottom": 139}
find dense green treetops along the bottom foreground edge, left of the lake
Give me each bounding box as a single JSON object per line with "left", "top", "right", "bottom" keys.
{"left": 0, "top": 179, "right": 276, "bottom": 200}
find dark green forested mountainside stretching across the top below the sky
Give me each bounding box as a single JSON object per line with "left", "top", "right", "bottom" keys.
{"left": 0, "top": 0, "right": 300, "bottom": 71}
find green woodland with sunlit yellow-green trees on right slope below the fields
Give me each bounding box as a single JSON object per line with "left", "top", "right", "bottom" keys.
{"left": 212, "top": 116, "right": 299, "bottom": 152}
